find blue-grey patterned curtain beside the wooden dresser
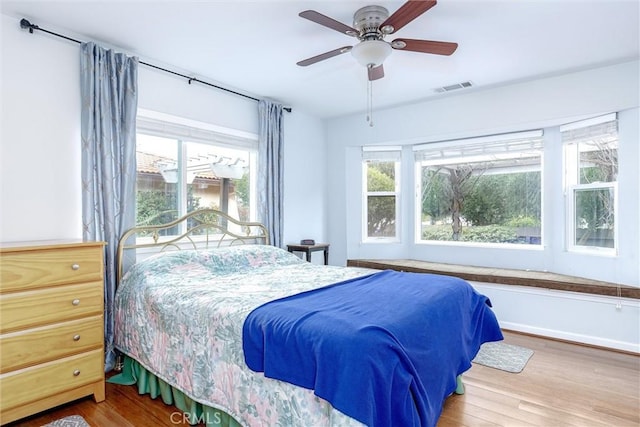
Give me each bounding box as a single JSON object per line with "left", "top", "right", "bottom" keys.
{"left": 80, "top": 43, "right": 138, "bottom": 371}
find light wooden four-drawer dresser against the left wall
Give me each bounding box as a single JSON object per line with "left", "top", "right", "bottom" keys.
{"left": 0, "top": 241, "right": 105, "bottom": 424}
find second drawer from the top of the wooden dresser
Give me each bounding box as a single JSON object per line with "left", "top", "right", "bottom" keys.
{"left": 0, "top": 282, "right": 104, "bottom": 333}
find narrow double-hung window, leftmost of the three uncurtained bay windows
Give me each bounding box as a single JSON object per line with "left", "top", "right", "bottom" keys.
{"left": 362, "top": 147, "right": 400, "bottom": 242}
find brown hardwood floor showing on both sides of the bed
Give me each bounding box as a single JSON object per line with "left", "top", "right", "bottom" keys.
{"left": 9, "top": 332, "right": 640, "bottom": 427}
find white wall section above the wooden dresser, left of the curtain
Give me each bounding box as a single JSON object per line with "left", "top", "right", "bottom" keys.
{"left": 0, "top": 15, "right": 82, "bottom": 241}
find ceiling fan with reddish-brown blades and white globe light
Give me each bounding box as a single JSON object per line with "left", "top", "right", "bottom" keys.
{"left": 297, "top": 0, "right": 458, "bottom": 81}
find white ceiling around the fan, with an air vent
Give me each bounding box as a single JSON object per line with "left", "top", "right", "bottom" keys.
{"left": 2, "top": 0, "right": 640, "bottom": 118}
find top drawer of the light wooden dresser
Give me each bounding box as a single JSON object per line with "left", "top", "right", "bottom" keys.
{"left": 0, "top": 244, "right": 104, "bottom": 292}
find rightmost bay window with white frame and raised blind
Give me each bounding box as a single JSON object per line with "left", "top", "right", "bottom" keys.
{"left": 560, "top": 114, "right": 618, "bottom": 252}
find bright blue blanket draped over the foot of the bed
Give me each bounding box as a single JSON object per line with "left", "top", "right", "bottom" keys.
{"left": 243, "top": 271, "right": 502, "bottom": 427}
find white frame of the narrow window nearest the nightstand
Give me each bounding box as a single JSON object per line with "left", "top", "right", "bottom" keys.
{"left": 361, "top": 146, "right": 402, "bottom": 243}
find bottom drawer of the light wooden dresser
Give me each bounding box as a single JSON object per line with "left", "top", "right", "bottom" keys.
{"left": 0, "top": 349, "right": 104, "bottom": 411}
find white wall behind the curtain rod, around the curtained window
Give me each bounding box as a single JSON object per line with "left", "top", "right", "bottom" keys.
{"left": 0, "top": 15, "right": 327, "bottom": 251}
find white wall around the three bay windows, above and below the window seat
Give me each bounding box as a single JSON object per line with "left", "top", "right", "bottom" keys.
{"left": 327, "top": 61, "right": 640, "bottom": 351}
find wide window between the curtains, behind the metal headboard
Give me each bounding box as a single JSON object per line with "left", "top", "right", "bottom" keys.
{"left": 136, "top": 117, "right": 257, "bottom": 234}
